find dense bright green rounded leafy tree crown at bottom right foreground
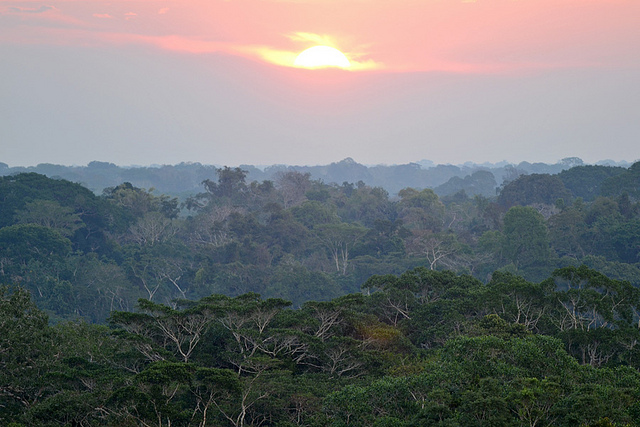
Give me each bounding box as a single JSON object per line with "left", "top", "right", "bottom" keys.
{"left": 325, "top": 336, "right": 638, "bottom": 426}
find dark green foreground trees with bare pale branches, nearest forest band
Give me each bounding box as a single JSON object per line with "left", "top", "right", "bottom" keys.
{"left": 0, "top": 266, "right": 640, "bottom": 426}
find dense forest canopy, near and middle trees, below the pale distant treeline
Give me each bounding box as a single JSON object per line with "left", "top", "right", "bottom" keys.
{"left": 0, "top": 163, "right": 640, "bottom": 426}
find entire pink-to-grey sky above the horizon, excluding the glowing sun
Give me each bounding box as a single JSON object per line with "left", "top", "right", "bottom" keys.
{"left": 0, "top": 0, "right": 640, "bottom": 166}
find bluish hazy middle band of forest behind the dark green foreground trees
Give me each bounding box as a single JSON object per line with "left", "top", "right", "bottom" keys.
{"left": 0, "top": 166, "right": 640, "bottom": 322}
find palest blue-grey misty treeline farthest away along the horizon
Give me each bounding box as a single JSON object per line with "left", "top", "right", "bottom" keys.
{"left": 0, "top": 157, "right": 633, "bottom": 197}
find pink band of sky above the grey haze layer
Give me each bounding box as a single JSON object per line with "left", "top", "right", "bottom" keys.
{"left": 5, "top": 0, "right": 640, "bottom": 72}
